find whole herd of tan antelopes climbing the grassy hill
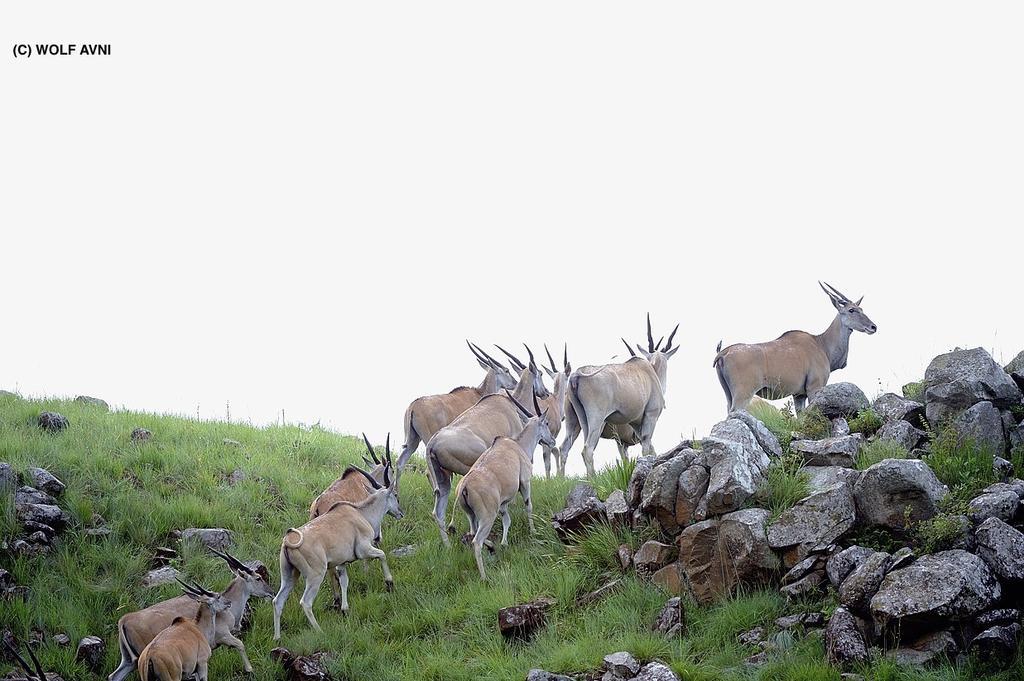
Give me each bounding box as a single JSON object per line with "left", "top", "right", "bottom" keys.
{"left": 72, "top": 284, "right": 878, "bottom": 681}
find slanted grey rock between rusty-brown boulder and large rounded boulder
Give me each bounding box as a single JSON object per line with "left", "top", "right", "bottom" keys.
{"left": 768, "top": 484, "right": 857, "bottom": 564}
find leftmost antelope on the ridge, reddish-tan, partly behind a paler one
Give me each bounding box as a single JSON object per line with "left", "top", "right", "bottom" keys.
{"left": 396, "top": 340, "right": 516, "bottom": 475}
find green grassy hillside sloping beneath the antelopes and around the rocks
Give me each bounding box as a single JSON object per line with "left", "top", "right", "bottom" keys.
{"left": 0, "top": 396, "right": 1015, "bottom": 681}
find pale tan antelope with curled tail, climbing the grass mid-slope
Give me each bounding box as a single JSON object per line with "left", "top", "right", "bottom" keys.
{"left": 273, "top": 444, "right": 401, "bottom": 640}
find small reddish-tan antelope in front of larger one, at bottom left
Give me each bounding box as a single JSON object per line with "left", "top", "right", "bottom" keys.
{"left": 138, "top": 580, "right": 231, "bottom": 681}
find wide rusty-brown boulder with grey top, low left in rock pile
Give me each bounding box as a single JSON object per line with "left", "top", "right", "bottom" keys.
{"left": 678, "top": 509, "right": 779, "bottom": 603}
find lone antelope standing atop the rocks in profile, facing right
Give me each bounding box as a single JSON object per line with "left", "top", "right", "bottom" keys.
{"left": 713, "top": 282, "right": 879, "bottom": 412}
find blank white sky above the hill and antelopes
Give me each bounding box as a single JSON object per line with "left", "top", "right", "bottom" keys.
{"left": 0, "top": 0, "right": 1024, "bottom": 471}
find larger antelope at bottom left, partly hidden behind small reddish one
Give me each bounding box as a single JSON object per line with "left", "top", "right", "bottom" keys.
{"left": 108, "top": 551, "right": 273, "bottom": 681}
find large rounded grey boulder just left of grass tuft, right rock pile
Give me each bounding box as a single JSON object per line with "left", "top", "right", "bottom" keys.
{"left": 853, "top": 459, "right": 949, "bottom": 529}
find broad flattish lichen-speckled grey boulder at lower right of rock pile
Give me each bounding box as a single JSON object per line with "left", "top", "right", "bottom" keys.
{"left": 870, "top": 549, "right": 1002, "bottom": 627}
